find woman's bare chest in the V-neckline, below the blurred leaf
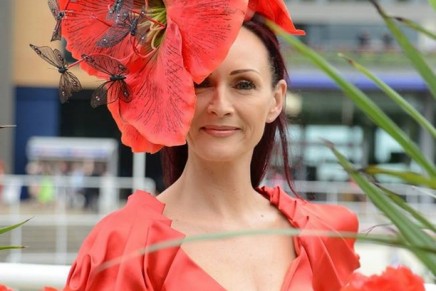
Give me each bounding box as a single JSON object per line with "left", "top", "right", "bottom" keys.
{"left": 182, "top": 235, "right": 295, "bottom": 291}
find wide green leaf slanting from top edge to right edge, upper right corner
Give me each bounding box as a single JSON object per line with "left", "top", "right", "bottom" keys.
{"left": 369, "top": 0, "right": 436, "bottom": 99}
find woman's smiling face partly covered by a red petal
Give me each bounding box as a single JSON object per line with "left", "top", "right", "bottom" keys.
{"left": 187, "top": 27, "right": 286, "bottom": 161}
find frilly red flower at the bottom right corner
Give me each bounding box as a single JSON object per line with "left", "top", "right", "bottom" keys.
{"left": 341, "top": 266, "right": 425, "bottom": 291}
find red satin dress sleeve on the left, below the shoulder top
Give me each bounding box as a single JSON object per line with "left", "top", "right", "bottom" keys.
{"left": 64, "top": 212, "right": 153, "bottom": 291}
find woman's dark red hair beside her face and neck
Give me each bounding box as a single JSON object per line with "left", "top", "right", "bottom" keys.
{"left": 161, "top": 15, "right": 295, "bottom": 193}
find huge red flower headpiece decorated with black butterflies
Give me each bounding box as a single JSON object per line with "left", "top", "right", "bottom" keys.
{"left": 32, "top": 0, "right": 304, "bottom": 153}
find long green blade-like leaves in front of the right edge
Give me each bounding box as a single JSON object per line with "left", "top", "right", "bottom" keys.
{"left": 270, "top": 0, "right": 436, "bottom": 276}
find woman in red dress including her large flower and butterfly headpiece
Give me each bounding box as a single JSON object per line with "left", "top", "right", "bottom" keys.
{"left": 32, "top": 0, "right": 359, "bottom": 291}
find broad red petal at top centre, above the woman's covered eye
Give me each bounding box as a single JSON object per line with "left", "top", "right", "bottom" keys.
{"left": 164, "top": 0, "right": 247, "bottom": 83}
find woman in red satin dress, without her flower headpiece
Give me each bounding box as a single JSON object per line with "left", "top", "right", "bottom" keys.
{"left": 66, "top": 17, "right": 359, "bottom": 290}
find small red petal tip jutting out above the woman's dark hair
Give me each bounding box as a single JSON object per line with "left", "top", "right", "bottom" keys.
{"left": 247, "top": 0, "right": 306, "bottom": 35}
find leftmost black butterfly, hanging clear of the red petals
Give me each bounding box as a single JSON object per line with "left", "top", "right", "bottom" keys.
{"left": 30, "top": 44, "right": 82, "bottom": 103}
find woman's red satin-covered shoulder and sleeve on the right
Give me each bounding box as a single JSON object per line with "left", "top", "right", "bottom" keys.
{"left": 261, "top": 187, "right": 359, "bottom": 290}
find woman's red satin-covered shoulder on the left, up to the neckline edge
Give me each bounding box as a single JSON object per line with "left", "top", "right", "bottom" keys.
{"left": 65, "top": 191, "right": 168, "bottom": 290}
